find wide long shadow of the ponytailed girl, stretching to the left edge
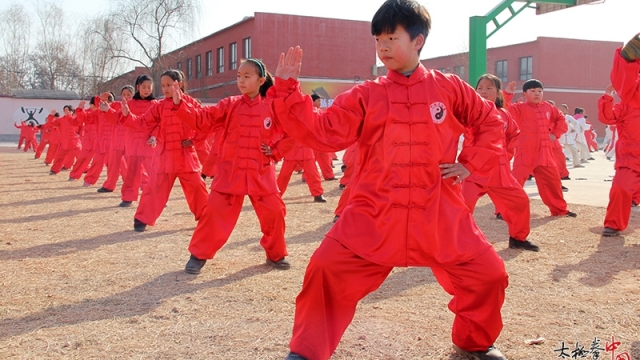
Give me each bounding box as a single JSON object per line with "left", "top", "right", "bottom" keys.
{"left": 0, "top": 265, "right": 272, "bottom": 338}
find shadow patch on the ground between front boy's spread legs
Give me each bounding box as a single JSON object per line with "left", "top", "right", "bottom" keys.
{"left": 361, "top": 267, "right": 437, "bottom": 304}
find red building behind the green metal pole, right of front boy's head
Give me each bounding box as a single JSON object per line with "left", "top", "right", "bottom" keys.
{"left": 410, "top": 37, "right": 623, "bottom": 137}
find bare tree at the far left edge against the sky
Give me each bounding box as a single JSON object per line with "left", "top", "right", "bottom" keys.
{"left": 0, "top": 3, "right": 31, "bottom": 94}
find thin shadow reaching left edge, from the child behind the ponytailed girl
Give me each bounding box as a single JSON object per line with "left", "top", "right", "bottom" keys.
{"left": 0, "top": 229, "right": 187, "bottom": 260}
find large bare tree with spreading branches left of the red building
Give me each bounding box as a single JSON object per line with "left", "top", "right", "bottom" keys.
{"left": 102, "top": 0, "right": 200, "bottom": 93}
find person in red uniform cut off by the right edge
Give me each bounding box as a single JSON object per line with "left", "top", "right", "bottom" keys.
{"left": 598, "top": 35, "right": 640, "bottom": 236}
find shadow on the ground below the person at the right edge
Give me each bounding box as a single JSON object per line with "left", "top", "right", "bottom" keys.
{"left": 551, "top": 236, "right": 640, "bottom": 287}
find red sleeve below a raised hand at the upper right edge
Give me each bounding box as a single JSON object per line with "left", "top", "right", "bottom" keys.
{"left": 611, "top": 48, "right": 640, "bottom": 108}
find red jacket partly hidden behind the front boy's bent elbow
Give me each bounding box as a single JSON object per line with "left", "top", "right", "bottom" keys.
{"left": 463, "top": 108, "right": 520, "bottom": 187}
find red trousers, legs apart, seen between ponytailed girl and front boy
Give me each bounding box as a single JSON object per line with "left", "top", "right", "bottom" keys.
{"left": 278, "top": 143, "right": 324, "bottom": 196}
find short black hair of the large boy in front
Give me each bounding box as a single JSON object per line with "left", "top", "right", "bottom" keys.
{"left": 371, "top": 0, "right": 431, "bottom": 53}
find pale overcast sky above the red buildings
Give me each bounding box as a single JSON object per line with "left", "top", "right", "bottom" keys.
{"left": 0, "top": 0, "right": 640, "bottom": 58}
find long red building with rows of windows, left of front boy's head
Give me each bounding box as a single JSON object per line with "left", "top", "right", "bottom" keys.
{"left": 102, "top": 13, "right": 376, "bottom": 102}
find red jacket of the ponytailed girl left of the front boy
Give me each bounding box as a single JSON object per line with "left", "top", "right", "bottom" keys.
{"left": 176, "top": 91, "right": 294, "bottom": 196}
